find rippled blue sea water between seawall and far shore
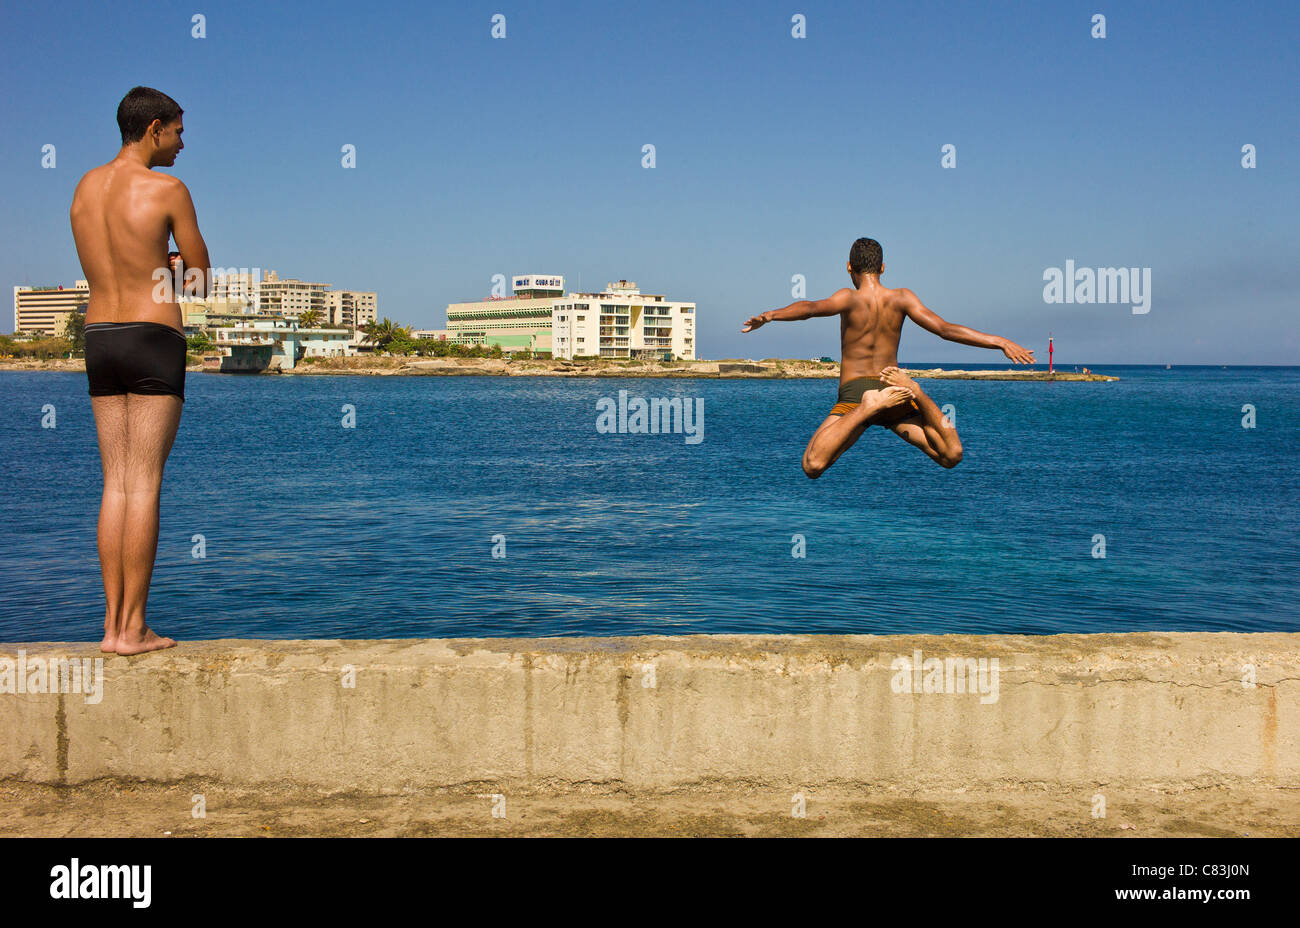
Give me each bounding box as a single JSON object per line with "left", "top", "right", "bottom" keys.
{"left": 0, "top": 364, "right": 1300, "bottom": 642}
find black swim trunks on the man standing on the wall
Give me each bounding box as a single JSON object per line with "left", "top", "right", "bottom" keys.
{"left": 86, "top": 322, "right": 186, "bottom": 403}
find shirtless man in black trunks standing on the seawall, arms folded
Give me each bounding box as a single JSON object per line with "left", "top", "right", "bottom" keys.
{"left": 69, "top": 87, "right": 209, "bottom": 654}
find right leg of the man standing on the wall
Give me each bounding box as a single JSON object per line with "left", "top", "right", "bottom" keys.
{"left": 117, "top": 394, "right": 182, "bottom": 654}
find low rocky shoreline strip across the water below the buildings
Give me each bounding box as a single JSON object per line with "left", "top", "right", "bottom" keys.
{"left": 0, "top": 357, "right": 1119, "bottom": 382}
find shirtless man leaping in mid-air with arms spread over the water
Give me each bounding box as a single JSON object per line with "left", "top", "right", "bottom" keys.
{"left": 741, "top": 238, "right": 1034, "bottom": 478}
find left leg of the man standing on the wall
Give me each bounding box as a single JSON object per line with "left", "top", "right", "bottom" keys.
{"left": 90, "top": 394, "right": 126, "bottom": 654}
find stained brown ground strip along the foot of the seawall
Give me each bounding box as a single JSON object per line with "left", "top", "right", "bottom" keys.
{"left": 0, "top": 777, "right": 1300, "bottom": 837}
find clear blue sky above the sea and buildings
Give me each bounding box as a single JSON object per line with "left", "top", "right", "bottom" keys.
{"left": 0, "top": 0, "right": 1300, "bottom": 364}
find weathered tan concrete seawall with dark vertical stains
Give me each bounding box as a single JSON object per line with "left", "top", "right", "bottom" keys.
{"left": 0, "top": 634, "right": 1300, "bottom": 797}
